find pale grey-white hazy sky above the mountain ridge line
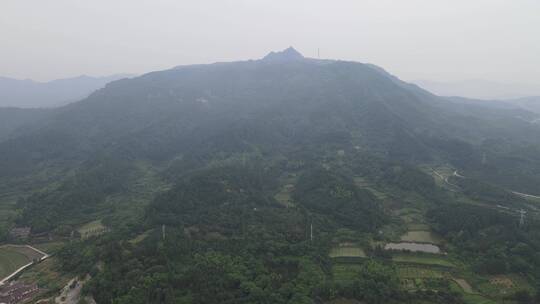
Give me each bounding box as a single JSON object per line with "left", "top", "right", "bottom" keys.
{"left": 0, "top": 0, "right": 540, "bottom": 85}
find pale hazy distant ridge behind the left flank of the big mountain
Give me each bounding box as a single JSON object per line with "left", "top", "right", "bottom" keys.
{"left": 0, "top": 74, "right": 131, "bottom": 108}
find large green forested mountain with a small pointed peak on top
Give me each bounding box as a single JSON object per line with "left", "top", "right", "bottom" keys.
{"left": 0, "top": 48, "right": 540, "bottom": 303}
